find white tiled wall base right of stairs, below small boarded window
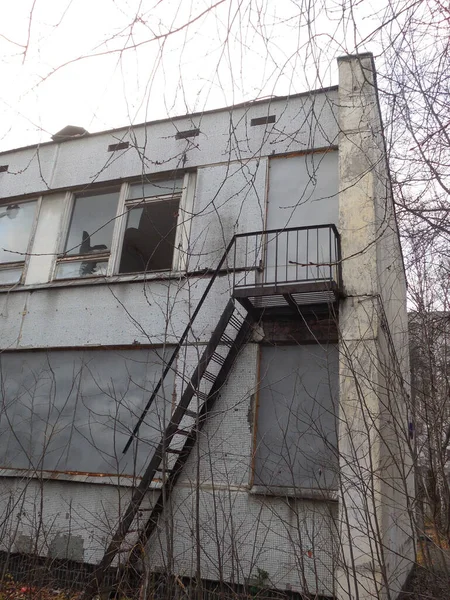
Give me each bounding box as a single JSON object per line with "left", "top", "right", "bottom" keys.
{"left": 146, "top": 485, "right": 337, "bottom": 597}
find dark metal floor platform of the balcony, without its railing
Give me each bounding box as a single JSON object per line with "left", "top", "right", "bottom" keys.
{"left": 233, "top": 280, "right": 339, "bottom": 318}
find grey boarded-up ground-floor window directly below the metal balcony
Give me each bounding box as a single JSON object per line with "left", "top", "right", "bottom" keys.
{"left": 254, "top": 344, "right": 338, "bottom": 489}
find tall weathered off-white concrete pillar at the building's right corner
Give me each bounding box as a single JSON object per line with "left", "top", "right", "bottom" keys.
{"left": 337, "top": 56, "right": 414, "bottom": 599}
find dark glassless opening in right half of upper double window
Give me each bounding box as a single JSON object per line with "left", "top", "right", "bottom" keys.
{"left": 119, "top": 198, "right": 180, "bottom": 273}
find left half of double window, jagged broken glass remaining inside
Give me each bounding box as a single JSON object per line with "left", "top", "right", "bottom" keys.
{"left": 56, "top": 188, "right": 119, "bottom": 279}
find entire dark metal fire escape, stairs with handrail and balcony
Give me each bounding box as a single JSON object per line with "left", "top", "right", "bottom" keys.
{"left": 84, "top": 225, "right": 340, "bottom": 600}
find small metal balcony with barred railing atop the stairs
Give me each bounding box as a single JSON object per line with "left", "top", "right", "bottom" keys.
{"left": 233, "top": 223, "right": 342, "bottom": 319}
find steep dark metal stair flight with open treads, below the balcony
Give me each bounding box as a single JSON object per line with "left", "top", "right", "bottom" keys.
{"left": 84, "top": 299, "right": 253, "bottom": 600}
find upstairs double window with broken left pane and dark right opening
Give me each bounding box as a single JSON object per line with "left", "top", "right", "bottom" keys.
{"left": 55, "top": 173, "right": 186, "bottom": 279}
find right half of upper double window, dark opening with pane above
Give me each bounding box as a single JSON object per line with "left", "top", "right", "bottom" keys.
{"left": 119, "top": 179, "right": 183, "bottom": 273}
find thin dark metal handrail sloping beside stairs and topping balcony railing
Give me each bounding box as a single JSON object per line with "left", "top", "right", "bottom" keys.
{"left": 122, "top": 223, "right": 341, "bottom": 454}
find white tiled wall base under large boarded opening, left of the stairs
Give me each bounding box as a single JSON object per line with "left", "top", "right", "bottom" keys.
{"left": 0, "top": 475, "right": 160, "bottom": 563}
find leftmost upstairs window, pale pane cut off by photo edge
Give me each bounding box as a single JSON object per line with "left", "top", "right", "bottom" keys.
{"left": 0, "top": 200, "right": 37, "bottom": 285}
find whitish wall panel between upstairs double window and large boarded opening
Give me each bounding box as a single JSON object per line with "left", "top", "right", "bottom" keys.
{"left": 17, "top": 282, "right": 168, "bottom": 348}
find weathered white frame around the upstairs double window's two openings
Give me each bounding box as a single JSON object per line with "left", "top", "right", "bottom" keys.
{"left": 51, "top": 172, "right": 196, "bottom": 282}
